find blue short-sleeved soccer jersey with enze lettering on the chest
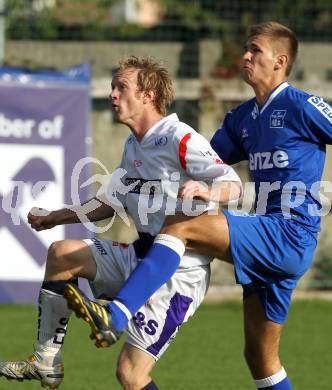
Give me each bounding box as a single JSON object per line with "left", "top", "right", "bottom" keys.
{"left": 211, "top": 82, "right": 332, "bottom": 233}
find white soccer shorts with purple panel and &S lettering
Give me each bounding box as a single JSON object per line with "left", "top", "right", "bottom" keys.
{"left": 84, "top": 239, "right": 210, "bottom": 360}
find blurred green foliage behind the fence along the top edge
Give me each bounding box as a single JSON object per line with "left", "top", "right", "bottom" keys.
{"left": 6, "top": 0, "right": 332, "bottom": 42}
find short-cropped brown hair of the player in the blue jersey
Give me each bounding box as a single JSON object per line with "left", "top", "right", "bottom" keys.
{"left": 248, "top": 22, "right": 299, "bottom": 76}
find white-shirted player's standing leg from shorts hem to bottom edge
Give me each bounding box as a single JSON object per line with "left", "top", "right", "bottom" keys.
{"left": 116, "top": 343, "right": 158, "bottom": 390}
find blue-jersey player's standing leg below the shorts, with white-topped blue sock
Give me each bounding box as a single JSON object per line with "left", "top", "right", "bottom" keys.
{"left": 243, "top": 294, "right": 291, "bottom": 390}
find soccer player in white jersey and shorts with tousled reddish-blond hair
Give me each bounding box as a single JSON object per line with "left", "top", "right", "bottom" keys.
{"left": 0, "top": 57, "right": 241, "bottom": 390}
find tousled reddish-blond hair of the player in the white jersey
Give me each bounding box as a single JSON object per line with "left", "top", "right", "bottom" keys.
{"left": 118, "top": 56, "right": 174, "bottom": 115}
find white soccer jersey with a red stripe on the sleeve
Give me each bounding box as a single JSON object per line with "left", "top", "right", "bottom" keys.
{"left": 109, "top": 114, "right": 240, "bottom": 265}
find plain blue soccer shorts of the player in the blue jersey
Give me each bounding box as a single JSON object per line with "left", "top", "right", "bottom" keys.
{"left": 224, "top": 210, "right": 317, "bottom": 324}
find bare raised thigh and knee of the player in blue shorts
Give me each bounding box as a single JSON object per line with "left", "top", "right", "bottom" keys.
{"left": 161, "top": 211, "right": 231, "bottom": 261}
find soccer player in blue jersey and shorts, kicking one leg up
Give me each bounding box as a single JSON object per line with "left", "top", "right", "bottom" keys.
{"left": 63, "top": 22, "right": 332, "bottom": 390}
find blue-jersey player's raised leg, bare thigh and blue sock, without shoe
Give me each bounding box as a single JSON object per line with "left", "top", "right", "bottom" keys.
{"left": 108, "top": 212, "right": 231, "bottom": 331}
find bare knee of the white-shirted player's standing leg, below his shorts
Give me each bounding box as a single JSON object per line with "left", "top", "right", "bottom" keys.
{"left": 117, "top": 343, "right": 156, "bottom": 388}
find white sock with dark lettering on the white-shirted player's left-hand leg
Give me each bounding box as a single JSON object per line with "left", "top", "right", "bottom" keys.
{"left": 36, "top": 289, "right": 72, "bottom": 366}
